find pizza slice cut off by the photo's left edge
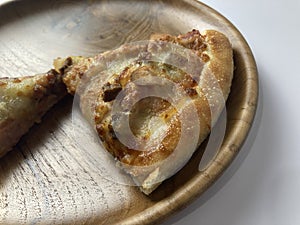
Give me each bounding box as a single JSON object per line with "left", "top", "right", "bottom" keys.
{"left": 0, "top": 70, "right": 67, "bottom": 156}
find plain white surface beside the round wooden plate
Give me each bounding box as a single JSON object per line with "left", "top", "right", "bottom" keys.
{"left": 163, "top": 0, "right": 300, "bottom": 225}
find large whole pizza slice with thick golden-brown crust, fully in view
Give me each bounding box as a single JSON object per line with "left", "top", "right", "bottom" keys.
{"left": 54, "top": 30, "right": 233, "bottom": 194}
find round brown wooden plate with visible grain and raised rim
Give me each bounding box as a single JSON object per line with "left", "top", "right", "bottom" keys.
{"left": 0, "top": 0, "right": 258, "bottom": 225}
